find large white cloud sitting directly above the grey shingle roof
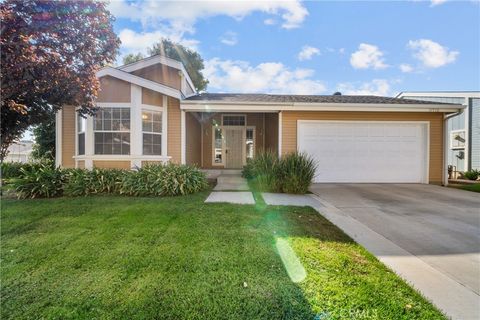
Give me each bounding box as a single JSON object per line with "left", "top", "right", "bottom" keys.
{"left": 203, "top": 58, "right": 326, "bottom": 94}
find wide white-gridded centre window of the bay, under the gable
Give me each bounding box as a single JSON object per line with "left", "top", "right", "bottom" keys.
{"left": 93, "top": 108, "right": 130, "bottom": 155}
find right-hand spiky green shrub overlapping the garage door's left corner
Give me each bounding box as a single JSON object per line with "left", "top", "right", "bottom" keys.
{"left": 279, "top": 153, "right": 316, "bottom": 194}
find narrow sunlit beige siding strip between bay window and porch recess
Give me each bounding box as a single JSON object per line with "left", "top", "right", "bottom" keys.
{"left": 167, "top": 97, "right": 182, "bottom": 163}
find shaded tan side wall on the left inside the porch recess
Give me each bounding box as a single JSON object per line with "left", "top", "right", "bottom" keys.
{"left": 185, "top": 112, "right": 202, "bottom": 166}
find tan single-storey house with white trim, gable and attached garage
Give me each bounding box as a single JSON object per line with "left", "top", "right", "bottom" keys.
{"left": 56, "top": 56, "right": 464, "bottom": 184}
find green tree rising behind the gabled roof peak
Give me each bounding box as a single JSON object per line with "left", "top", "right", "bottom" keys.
{"left": 123, "top": 39, "right": 208, "bottom": 91}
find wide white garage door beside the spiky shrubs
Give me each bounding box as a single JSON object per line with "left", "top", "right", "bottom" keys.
{"left": 297, "top": 120, "right": 428, "bottom": 183}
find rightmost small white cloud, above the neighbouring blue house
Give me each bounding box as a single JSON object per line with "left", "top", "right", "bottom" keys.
{"left": 408, "top": 39, "right": 459, "bottom": 68}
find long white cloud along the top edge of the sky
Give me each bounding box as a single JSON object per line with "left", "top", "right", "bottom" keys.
{"left": 108, "top": 0, "right": 308, "bottom": 33}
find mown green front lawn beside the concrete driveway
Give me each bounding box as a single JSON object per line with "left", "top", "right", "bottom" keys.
{"left": 1, "top": 192, "right": 443, "bottom": 320}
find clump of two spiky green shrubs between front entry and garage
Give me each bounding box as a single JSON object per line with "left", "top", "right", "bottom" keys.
{"left": 242, "top": 152, "right": 316, "bottom": 194}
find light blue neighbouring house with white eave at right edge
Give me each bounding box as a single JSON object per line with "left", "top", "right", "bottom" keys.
{"left": 397, "top": 91, "right": 480, "bottom": 172}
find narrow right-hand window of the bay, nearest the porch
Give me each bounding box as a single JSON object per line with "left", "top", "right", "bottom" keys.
{"left": 142, "top": 110, "right": 162, "bottom": 155}
